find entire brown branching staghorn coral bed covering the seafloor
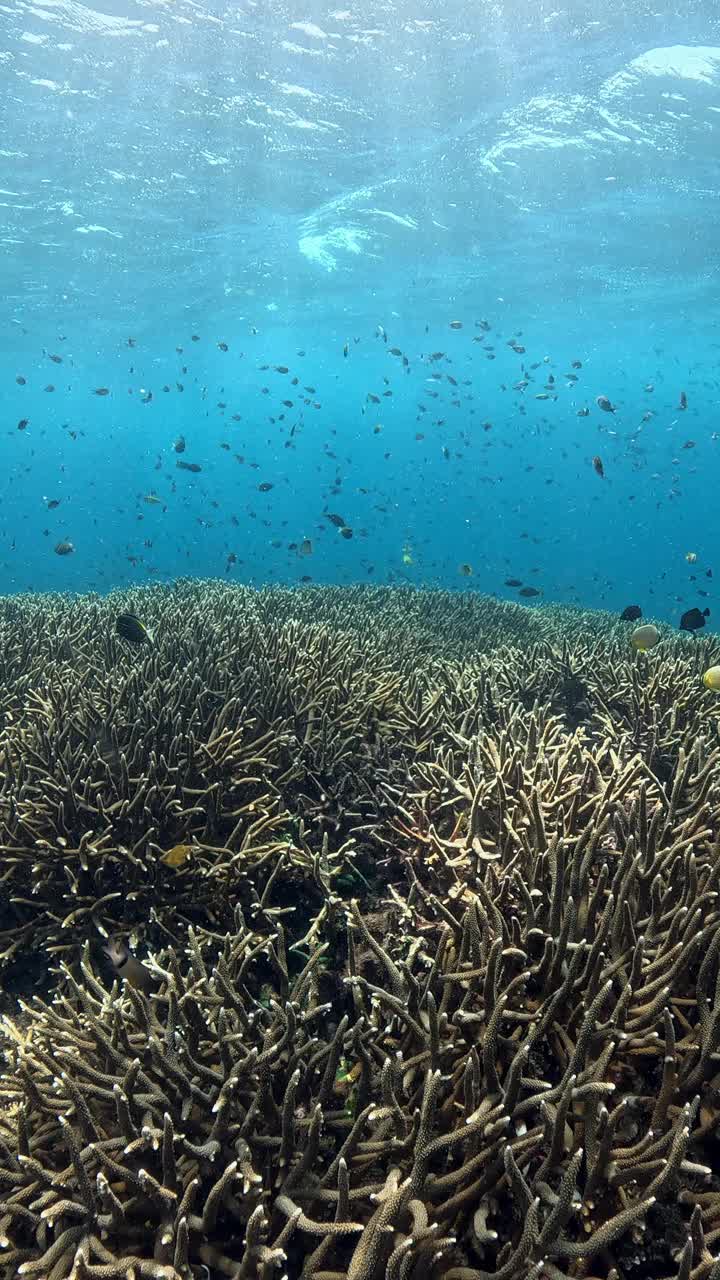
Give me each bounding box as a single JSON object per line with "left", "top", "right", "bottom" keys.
{"left": 0, "top": 584, "right": 720, "bottom": 1280}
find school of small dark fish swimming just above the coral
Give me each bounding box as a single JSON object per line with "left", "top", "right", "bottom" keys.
{"left": 0, "top": 317, "right": 719, "bottom": 632}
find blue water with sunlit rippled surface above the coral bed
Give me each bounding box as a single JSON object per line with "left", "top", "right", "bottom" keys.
{"left": 0, "top": 0, "right": 720, "bottom": 627}
